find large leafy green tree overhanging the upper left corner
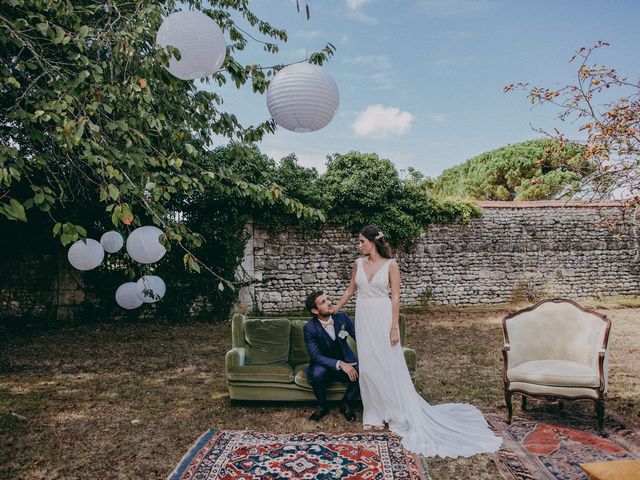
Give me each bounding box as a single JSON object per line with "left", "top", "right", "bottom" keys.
{"left": 0, "top": 0, "right": 333, "bottom": 284}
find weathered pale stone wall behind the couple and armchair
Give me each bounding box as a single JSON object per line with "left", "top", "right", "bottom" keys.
{"left": 241, "top": 202, "right": 640, "bottom": 313}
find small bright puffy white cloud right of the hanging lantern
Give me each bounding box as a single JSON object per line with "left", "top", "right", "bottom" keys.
{"left": 353, "top": 105, "right": 413, "bottom": 138}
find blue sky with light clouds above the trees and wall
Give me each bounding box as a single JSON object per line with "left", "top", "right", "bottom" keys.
{"left": 201, "top": 0, "right": 640, "bottom": 176}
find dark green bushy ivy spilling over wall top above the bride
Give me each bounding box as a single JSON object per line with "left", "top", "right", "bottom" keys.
{"left": 275, "top": 152, "right": 478, "bottom": 246}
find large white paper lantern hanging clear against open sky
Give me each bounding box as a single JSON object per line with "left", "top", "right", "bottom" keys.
{"left": 267, "top": 63, "right": 340, "bottom": 132}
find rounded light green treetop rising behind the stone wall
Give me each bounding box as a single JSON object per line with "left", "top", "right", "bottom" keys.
{"left": 433, "top": 139, "right": 592, "bottom": 200}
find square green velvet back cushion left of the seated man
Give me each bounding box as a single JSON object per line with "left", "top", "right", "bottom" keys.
{"left": 244, "top": 318, "right": 291, "bottom": 365}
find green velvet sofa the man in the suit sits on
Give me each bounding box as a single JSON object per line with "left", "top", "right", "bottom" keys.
{"left": 224, "top": 314, "right": 416, "bottom": 401}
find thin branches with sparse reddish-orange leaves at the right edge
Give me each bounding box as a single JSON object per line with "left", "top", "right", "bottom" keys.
{"left": 505, "top": 41, "right": 640, "bottom": 205}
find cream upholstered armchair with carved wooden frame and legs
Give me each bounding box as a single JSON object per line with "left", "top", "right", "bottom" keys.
{"left": 502, "top": 299, "right": 611, "bottom": 433}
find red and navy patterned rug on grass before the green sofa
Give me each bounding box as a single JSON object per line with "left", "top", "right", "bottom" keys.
{"left": 169, "top": 430, "right": 429, "bottom": 480}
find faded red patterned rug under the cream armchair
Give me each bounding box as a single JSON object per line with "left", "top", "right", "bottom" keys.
{"left": 486, "top": 405, "right": 640, "bottom": 480}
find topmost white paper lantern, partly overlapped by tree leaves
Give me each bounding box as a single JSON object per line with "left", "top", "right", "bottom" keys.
{"left": 156, "top": 11, "right": 227, "bottom": 80}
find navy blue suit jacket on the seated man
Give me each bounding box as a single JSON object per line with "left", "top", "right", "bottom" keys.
{"left": 303, "top": 312, "right": 357, "bottom": 376}
